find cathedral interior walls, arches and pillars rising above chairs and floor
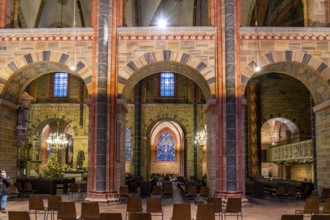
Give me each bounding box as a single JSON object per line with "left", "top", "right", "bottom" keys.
{"left": 0, "top": 0, "right": 330, "bottom": 199}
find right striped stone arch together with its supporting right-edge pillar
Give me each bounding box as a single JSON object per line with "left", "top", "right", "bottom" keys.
{"left": 241, "top": 51, "right": 330, "bottom": 189}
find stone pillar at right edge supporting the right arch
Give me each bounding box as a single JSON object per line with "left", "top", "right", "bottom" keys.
{"left": 313, "top": 101, "right": 330, "bottom": 192}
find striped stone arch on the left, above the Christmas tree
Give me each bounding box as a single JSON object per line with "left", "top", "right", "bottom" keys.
{"left": 0, "top": 51, "right": 92, "bottom": 103}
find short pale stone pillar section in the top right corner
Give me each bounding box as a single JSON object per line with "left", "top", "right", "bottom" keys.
{"left": 303, "top": 0, "right": 330, "bottom": 27}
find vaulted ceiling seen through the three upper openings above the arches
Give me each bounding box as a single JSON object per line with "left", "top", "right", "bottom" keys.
{"left": 12, "top": 0, "right": 304, "bottom": 28}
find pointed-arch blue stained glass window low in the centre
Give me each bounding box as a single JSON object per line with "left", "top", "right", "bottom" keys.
{"left": 157, "top": 131, "right": 175, "bottom": 161}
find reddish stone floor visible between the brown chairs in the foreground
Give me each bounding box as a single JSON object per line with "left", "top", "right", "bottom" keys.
{"left": 0, "top": 187, "right": 320, "bottom": 220}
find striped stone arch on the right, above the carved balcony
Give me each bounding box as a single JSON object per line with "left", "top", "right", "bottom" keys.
{"left": 241, "top": 51, "right": 330, "bottom": 105}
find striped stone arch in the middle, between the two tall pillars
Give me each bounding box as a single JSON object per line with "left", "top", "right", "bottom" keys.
{"left": 118, "top": 50, "right": 215, "bottom": 99}
